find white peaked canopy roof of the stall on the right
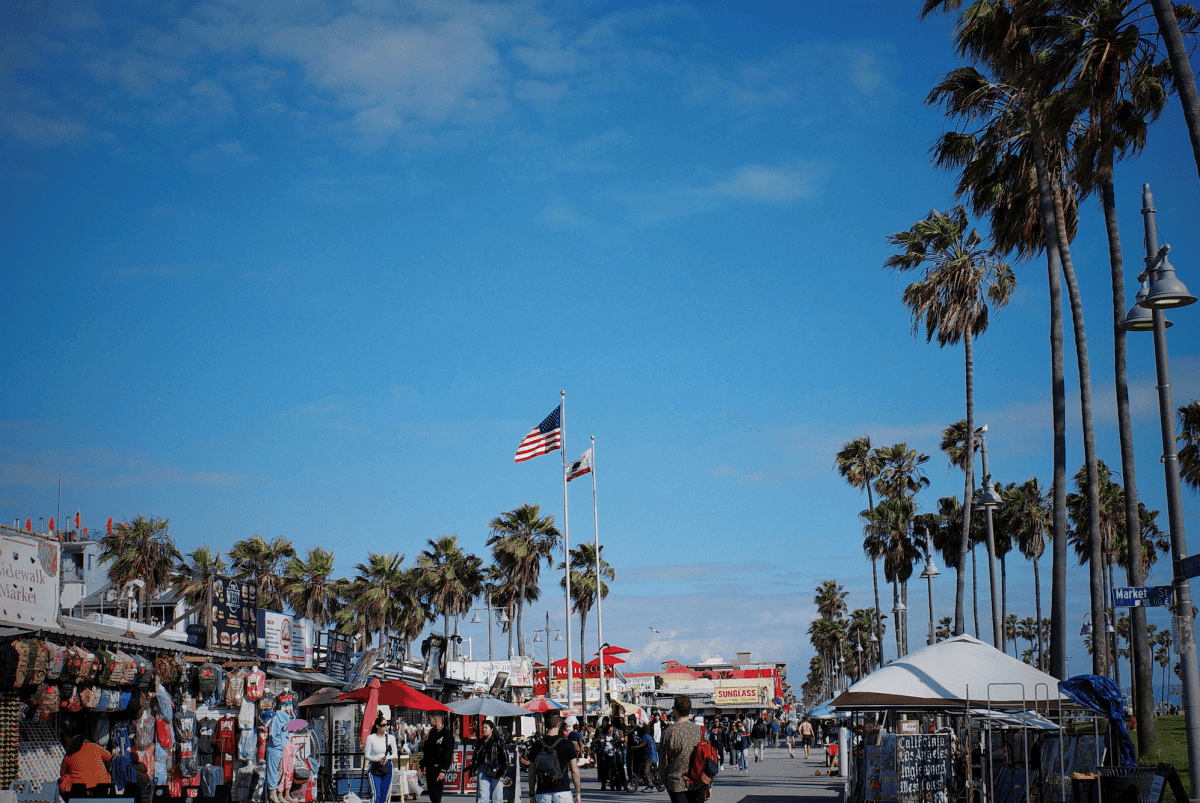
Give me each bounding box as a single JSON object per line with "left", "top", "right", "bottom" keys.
{"left": 833, "top": 635, "right": 1060, "bottom": 709}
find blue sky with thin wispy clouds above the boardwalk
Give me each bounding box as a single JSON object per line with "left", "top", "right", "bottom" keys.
{"left": 0, "top": 0, "right": 1200, "bottom": 681}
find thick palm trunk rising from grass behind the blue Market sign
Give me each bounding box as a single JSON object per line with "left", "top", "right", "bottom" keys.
{"left": 1100, "top": 172, "right": 1158, "bottom": 755}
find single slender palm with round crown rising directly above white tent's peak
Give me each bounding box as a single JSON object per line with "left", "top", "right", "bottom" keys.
{"left": 883, "top": 206, "right": 1016, "bottom": 635}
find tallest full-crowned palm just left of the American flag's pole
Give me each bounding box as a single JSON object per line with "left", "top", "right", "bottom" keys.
{"left": 487, "top": 504, "right": 562, "bottom": 655}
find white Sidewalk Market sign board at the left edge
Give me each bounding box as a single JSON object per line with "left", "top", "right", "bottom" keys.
{"left": 0, "top": 534, "right": 61, "bottom": 628}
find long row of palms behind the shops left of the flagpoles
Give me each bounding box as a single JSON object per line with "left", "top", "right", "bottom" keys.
{"left": 101, "top": 504, "right": 616, "bottom": 657}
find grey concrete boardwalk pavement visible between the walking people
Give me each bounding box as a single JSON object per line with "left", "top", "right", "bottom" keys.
{"left": 581, "top": 743, "right": 842, "bottom": 803}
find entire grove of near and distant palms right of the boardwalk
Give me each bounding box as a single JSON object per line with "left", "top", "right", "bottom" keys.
{"left": 803, "top": 0, "right": 1200, "bottom": 754}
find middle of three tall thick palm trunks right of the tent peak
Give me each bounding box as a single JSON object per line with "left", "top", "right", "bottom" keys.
{"left": 1054, "top": 184, "right": 1109, "bottom": 675}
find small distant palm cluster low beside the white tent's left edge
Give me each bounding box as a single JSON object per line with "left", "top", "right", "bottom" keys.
{"left": 800, "top": 580, "right": 882, "bottom": 708}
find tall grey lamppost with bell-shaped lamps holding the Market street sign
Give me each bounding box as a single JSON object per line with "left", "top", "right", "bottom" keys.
{"left": 1124, "top": 184, "right": 1200, "bottom": 802}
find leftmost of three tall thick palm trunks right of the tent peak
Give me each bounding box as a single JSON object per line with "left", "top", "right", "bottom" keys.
{"left": 1028, "top": 114, "right": 1067, "bottom": 681}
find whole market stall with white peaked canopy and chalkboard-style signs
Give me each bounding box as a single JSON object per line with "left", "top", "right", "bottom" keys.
{"left": 828, "top": 635, "right": 1105, "bottom": 803}
